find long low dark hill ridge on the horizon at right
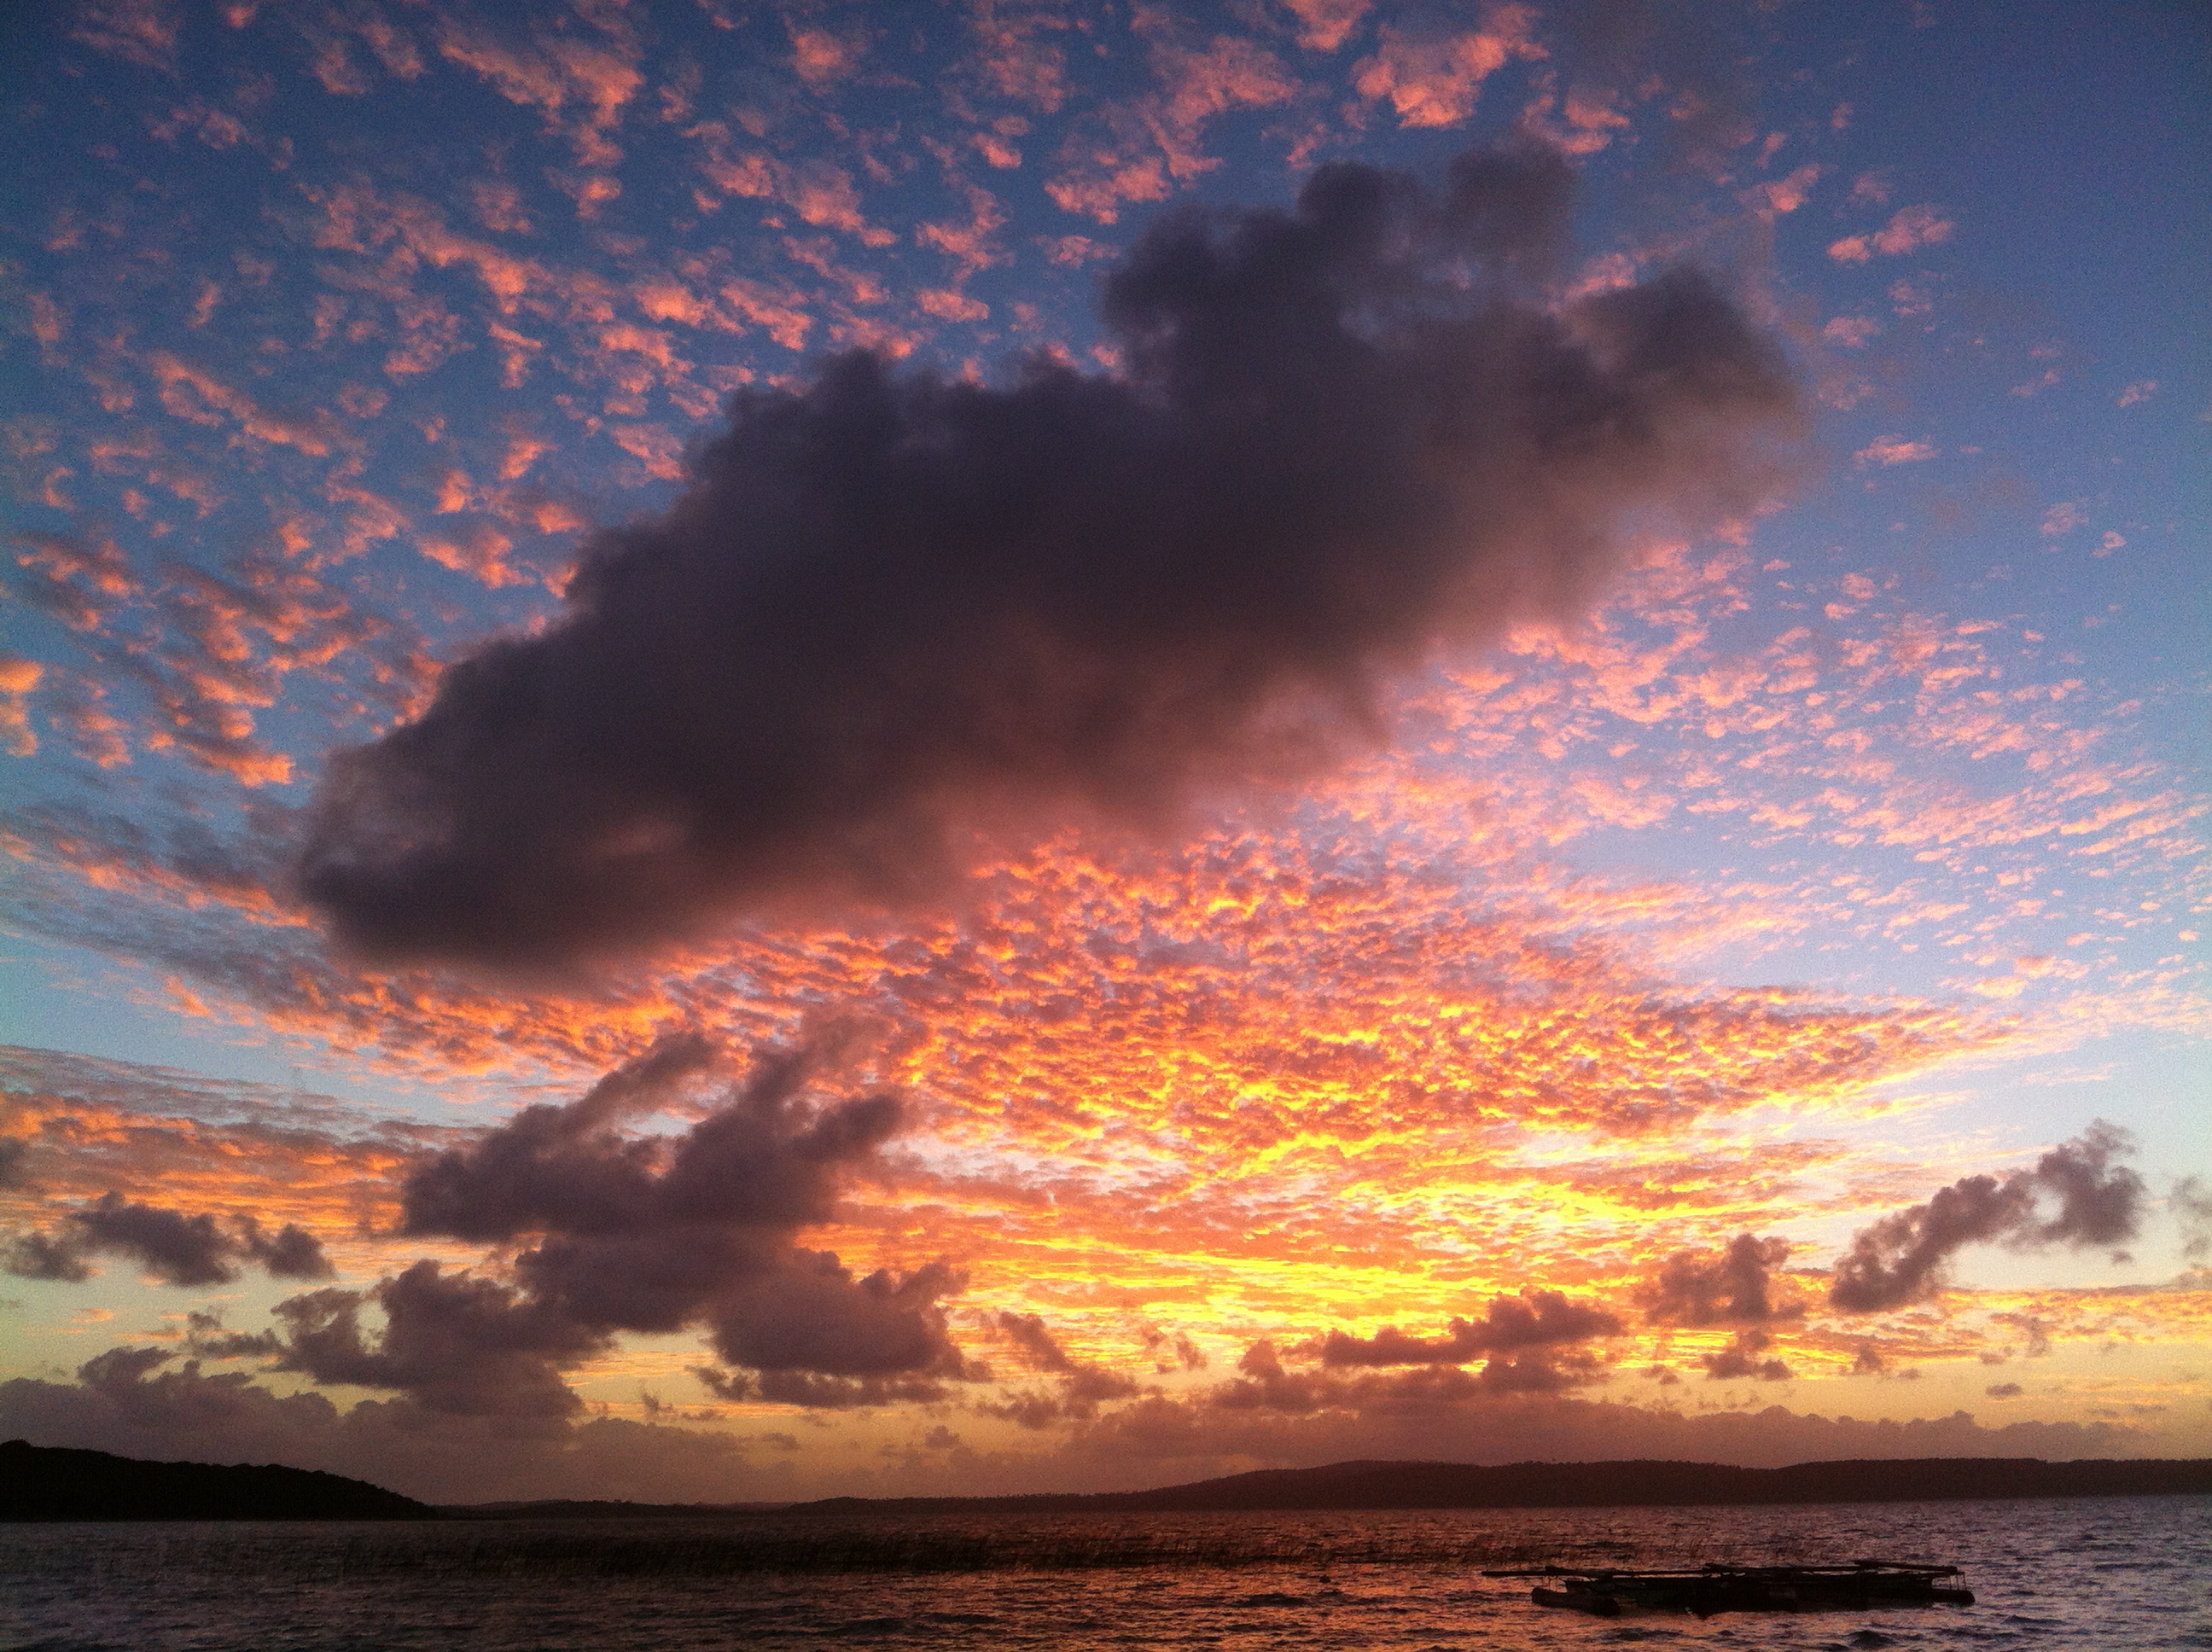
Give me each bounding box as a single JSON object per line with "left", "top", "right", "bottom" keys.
{"left": 795, "top": 1457, "right": 2212, "bottom": 1513}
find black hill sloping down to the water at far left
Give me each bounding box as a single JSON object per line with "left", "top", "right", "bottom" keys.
{"left": 0, "top": 1440, "right": 438, "bottom": 1519}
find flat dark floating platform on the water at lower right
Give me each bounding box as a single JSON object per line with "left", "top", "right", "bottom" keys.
{"left": 1484, "top": 1559, "right": 1973, "bottom": 1617}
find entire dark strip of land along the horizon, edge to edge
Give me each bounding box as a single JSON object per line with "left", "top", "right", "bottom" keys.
{"left": 0, "top": 1440, "right": 2212, "bottom": 1519}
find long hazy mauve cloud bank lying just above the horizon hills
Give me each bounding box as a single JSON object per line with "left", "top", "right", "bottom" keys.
{"left": 0, "top": 1349, "right": 2141, "bottom": 1502}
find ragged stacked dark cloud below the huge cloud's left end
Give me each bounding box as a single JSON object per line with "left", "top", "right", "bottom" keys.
{"left": 233, "top": 1035, "right": 964, "bottom": 1417}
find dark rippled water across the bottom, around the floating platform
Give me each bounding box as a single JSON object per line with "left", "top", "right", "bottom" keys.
{"left": 0, "top": 1498, "right": 2212, "bottom": 1652}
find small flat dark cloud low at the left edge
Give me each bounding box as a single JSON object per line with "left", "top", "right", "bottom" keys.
{"left": 0, "top": 1192, "right": 332, "bottom": 1285}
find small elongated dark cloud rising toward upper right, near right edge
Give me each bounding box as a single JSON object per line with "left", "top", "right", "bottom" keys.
{"left": 1827, "top": 1119, "right": 2145, "bottom": 1313}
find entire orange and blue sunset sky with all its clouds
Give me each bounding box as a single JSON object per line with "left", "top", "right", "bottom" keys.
{"left": 0, "top": 0, "right": 2212, "bottom": 1502}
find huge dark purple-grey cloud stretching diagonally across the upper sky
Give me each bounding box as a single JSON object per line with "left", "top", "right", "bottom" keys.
{"left": 296, "top": 150, "right": 1796, "bottom": 967}
